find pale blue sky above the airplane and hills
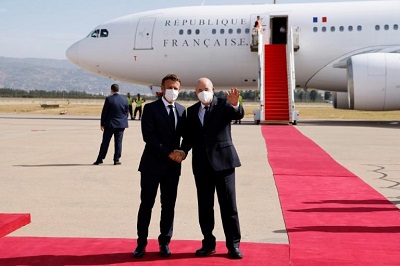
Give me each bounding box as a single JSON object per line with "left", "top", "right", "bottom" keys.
{"left": 0, "top": 0, "right": 372, "bottom": 59}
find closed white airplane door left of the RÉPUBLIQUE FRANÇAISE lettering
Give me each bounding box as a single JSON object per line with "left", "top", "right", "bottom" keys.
{"left": 133, "top": 18, "right": 156, "bottom": 50}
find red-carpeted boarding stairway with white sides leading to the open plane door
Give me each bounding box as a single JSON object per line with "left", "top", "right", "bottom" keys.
{"left": 252, "top": 27, "right": 298, "bottom": 124}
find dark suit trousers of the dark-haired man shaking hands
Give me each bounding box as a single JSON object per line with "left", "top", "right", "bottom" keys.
{"left": 137, "top": 171, "right": 179, "bottom": 247}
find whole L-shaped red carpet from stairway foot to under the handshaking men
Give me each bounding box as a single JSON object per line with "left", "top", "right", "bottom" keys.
{"left": 0, "top": 125, "right": 400, "bottom": 266}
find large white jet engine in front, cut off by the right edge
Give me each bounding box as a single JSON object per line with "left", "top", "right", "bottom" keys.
{"left": 347, "top": 53, "right": 400, "bottom": 111}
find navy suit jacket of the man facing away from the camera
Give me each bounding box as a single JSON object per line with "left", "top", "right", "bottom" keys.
{"left": 100, "top": 93, "right": 129, "bottom": 128}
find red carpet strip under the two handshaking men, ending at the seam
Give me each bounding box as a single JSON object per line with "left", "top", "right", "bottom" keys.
{"left": 0, "top": 237, "right": 289, "bottom": 266}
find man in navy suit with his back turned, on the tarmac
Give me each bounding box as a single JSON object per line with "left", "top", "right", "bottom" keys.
{"left": 93, "top": 84, "right": 129, "bottom": 165}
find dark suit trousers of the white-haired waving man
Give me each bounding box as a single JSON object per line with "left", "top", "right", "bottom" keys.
{"left": 195, "top": 165, "right": 241, "bottom": 249}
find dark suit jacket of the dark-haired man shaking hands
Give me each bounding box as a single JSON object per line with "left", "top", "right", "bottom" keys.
{"left": 139, "top": 98, "right": 186, "bottom": 175}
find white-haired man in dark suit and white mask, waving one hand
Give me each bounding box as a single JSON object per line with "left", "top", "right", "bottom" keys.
{"left": 182, "top": 78, "right": 244, "bottom": 259}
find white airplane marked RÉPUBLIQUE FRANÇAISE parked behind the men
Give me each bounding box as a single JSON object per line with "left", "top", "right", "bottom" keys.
{"left": 66, "top": 1, "right": 400, "bottom": 111}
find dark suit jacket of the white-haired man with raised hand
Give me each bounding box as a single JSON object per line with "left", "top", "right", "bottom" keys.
{"left": 182, "top": 97, "right": 244, "bottom": 175}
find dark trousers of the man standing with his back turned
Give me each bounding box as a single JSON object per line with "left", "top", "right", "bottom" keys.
{"left": 97, "top": 127, "right": 125, "bottom": 161}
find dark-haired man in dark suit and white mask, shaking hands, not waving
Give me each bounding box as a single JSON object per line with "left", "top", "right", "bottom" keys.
{"left": 133, "top": 74, "right": 186, "bottom": 258}
